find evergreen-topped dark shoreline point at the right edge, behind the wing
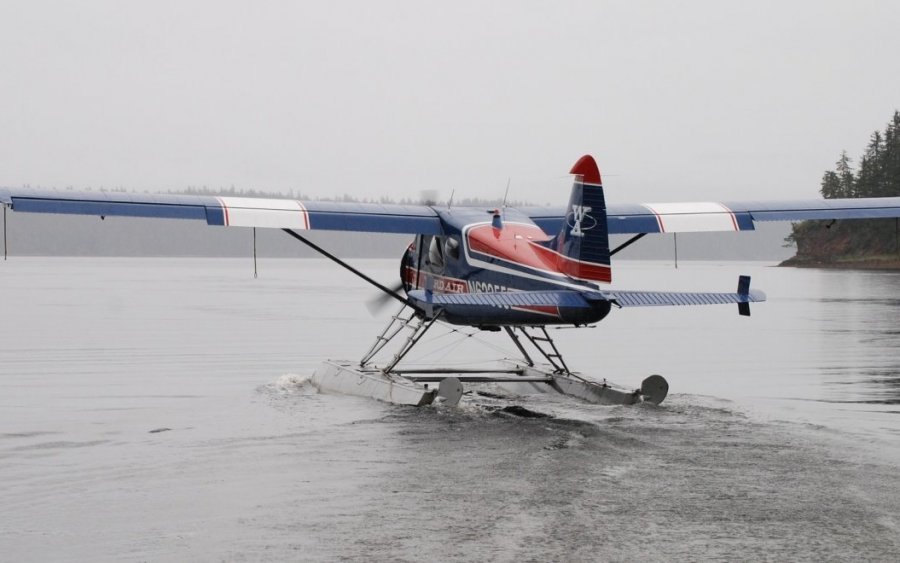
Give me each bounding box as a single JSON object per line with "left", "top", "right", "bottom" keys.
{"left": 787, "top": 111, "right": 900, "bottom": 266}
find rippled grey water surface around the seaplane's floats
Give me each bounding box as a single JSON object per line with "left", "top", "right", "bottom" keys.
{"left": 0, "top": 258, "right": 900, "bottom": 561}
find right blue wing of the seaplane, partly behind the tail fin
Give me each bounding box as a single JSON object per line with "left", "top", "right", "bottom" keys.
{"left": 519, "top": 197, "right": 900, "bottom": 235}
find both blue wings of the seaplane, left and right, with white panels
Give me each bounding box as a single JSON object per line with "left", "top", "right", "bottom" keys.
{"left": 7, "top": 188, "right": 900, "bottom": 235}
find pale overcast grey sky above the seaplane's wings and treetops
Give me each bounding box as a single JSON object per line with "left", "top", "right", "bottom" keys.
{"left": 0, "top": 0, "right": 900, "bottom": 203}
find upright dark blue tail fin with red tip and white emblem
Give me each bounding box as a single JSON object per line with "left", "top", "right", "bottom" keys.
{"left": 551, "top": 155, "right": 612, "bottom": 283}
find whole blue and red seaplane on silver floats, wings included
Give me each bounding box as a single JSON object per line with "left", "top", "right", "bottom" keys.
{"left": 0, "top": 155, "right": 900, "bottom": 406}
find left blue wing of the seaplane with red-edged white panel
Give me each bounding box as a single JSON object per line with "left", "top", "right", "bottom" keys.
{"left": 0, "top": 188, "right": 441, "bottom": 235}
